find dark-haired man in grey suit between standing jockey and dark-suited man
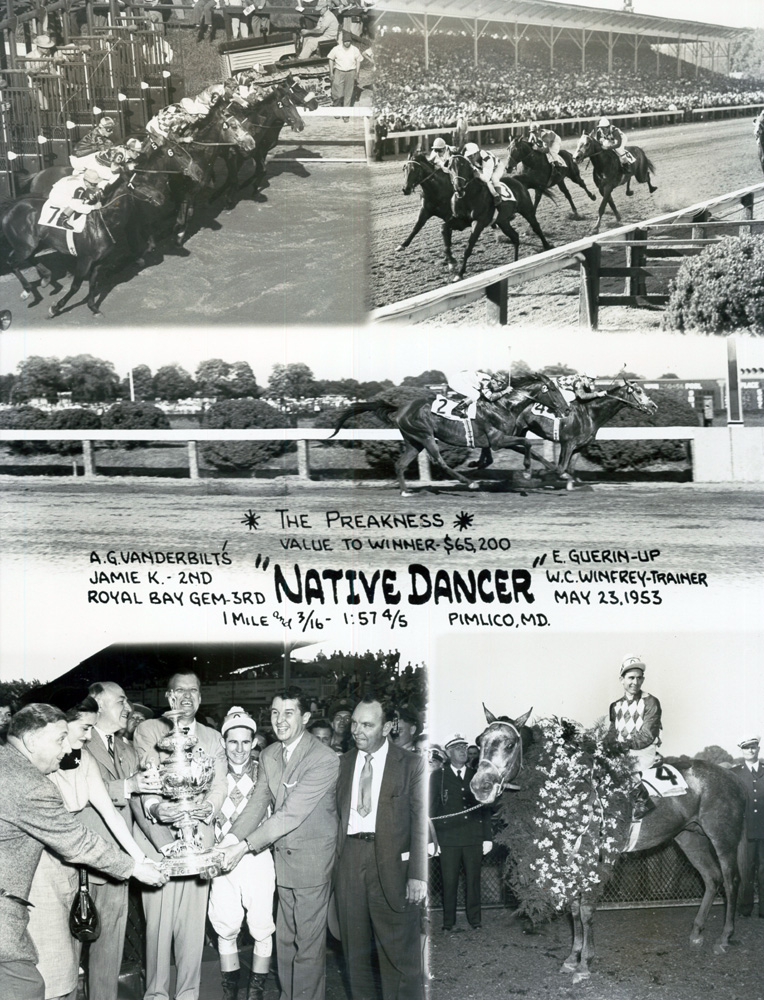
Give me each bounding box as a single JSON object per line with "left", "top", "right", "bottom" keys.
{"left": 221, "top": 688, "right": 339, "bottom": 1000}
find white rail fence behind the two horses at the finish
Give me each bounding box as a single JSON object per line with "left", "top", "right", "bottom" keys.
{"left": 0, "top": 425, "right": 764, "bottom": 483}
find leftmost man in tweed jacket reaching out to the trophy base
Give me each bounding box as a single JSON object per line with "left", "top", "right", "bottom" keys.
{"left": 0, "top": 704, "right": 163, "bottom": 1000}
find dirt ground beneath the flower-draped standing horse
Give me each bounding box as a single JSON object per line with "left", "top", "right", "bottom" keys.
{"left": 430, "top": 906, "right": 764, "bottom": 1000}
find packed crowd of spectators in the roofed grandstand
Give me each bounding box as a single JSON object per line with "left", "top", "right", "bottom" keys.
{"left": 375, "top": 31, "right": 764, "bottom": 132}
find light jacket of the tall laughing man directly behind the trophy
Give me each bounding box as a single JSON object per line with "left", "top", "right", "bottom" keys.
{"left": 130, "top": 718, "right": 228, "bottom": 860}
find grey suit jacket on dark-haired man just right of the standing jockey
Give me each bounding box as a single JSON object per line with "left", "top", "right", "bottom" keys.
{"left": 231, "top": 732, "right": 339, "bottom": 889}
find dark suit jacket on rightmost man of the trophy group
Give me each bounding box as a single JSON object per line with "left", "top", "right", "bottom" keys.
{"left": 337, "top": 743, "right": 427, "bottom": 912}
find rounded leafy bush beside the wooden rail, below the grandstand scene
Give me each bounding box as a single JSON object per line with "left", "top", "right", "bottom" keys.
{"left": 662, "top": 236, "right": 764, "bottom": 334}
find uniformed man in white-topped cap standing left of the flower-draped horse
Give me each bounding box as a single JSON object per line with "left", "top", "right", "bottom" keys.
{"left": 430, "top": 733, "right": 493, "bottom": 931}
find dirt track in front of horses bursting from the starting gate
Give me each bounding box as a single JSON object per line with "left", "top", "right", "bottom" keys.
{"left": 0, "top": 118, "right": 368, "bottom": 330}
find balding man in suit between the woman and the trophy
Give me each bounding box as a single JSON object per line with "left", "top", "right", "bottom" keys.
{"left": 79, "top": 681, "right": 160, "bottom": 1000}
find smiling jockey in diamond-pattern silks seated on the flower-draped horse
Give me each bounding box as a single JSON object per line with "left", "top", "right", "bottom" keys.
{"left": 607, "top": 656, "right": 662, "bottom": 820}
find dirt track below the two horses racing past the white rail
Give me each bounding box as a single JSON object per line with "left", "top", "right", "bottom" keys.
{"left": 0, "top": 476, "right": 764, "bottom": 585}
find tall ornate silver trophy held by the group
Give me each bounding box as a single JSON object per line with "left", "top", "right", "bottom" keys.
{"left": 157, "top": 710, "right": 223, "bottom": 879}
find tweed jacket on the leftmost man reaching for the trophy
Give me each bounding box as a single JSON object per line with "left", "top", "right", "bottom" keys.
{"left": 0, "top": 746, "right": 134, "bottom": 962}
